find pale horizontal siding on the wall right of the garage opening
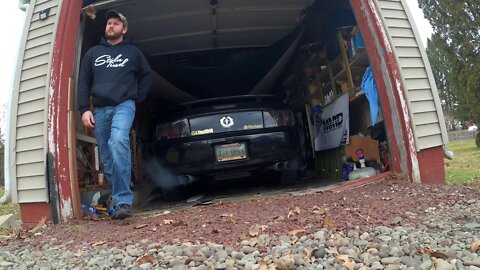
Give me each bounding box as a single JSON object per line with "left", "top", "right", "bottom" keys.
{"left": 377, "top": 0, "right": 448, "bottom": 151}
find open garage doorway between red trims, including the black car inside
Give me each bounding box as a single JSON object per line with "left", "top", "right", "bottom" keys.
{"left": 76, "top": 0, "right": 391, "bottom": 207}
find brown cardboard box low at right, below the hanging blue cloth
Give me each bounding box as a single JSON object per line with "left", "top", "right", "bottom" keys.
{"left": 345, "top": 136, "right": 380, "bottom": 162}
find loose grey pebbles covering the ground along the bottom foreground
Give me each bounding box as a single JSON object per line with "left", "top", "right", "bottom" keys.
{"left": 0, "top": 192, "right": 480, "bottom": 270}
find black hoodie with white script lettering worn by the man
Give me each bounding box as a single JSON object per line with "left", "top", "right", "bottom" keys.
{"left": 77, "top": 39, "right": 153, "bottom": 114}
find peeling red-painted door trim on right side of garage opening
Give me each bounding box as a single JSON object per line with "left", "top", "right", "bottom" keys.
{"left": 350, "top": 0, "right": 416, "bottom": 180}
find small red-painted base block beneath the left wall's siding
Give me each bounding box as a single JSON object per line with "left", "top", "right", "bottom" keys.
{"left": 20, "top": 203, "right": 52, "bottom": 228}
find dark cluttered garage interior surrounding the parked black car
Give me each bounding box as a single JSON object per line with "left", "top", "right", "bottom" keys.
{"left": 76, "top": 0, "right": 391, "bottom": 211}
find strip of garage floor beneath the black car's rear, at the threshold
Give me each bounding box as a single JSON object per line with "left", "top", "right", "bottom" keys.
{"left": 134, "top": 172, "right": 390, "bottom": 215}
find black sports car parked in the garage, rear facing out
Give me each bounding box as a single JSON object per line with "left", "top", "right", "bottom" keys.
{"left": 155, "top": 95, "right": 304, "bottom": 190}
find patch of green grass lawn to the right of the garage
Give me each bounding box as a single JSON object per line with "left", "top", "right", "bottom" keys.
{"left": 445, "top": 139, "right": 480, "bottom": 186}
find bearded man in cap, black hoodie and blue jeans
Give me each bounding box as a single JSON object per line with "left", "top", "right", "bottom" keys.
{"left": 77, "top": 10, "right": 152, "bottom": 219}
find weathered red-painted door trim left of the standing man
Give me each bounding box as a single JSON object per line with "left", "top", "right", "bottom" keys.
{"left": 48, "top": 0, "right": 82, "bottom": 221}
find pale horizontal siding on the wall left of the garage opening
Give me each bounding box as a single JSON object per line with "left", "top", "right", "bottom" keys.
{"left": 9, "top": 0, "right": 59, "bottom": 203}
